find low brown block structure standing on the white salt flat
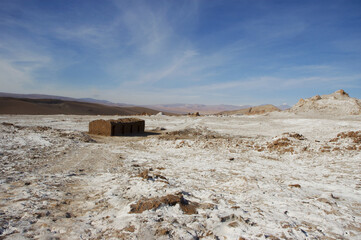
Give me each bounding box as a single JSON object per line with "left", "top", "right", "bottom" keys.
{"left": 89, "top": 118, "right": 145, "bottom": 136}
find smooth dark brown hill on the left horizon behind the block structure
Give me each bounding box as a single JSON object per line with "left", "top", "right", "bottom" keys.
{"left": 0, "top": 97, "right": 167, "bottom": 115}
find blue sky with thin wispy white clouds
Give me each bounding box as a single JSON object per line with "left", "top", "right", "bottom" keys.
{"left": 0, "top": 0, "right": 361, "bottom": 105}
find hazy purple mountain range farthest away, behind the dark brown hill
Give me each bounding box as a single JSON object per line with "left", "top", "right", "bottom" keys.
{"left": 0, "top": 92, "right": 290, "bottom": 114}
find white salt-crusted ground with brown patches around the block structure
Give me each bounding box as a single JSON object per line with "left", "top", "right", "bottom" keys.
{"left": 0, "top": 113, "right": 361, "bottom": 239}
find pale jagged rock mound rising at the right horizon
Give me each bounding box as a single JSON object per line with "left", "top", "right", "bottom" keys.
{"left": 289, "top": 89, "right": 361, "bottom": 115}
